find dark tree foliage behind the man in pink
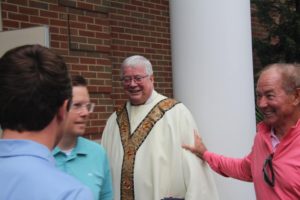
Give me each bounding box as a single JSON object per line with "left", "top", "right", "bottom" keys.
{"left": 251, "top": 0, "right": 300, "bottom": 66}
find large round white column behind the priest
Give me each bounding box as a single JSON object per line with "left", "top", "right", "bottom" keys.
{"left": 170, "top": 0, "right": 255, "bottom": 200}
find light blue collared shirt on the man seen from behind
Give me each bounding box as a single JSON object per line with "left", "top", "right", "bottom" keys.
{"left": 0, "top": 139, "right": 93, "bottom": 200}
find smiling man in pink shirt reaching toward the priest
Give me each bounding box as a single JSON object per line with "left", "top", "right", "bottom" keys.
{"left": 183, "top": 63, "right": 300, "bottom": 200}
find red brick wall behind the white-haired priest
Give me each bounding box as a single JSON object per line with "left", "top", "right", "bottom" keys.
{"left": 1, "top": 0, "right": 173, "bottom": 139}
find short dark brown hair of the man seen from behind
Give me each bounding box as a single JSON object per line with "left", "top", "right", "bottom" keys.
{"left": 0, "top": 45, "right": 72, "bottom": 131}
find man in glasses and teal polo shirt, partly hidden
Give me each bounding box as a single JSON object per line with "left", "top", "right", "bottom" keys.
{"left": 53, "top": 75, "right": 113, "bottom": 200}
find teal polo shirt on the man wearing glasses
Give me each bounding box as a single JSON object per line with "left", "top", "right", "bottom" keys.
{"left": 53, "top": 137, "right": 113, "bottom": 200}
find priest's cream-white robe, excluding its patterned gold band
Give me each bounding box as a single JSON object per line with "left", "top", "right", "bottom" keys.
{"left": 101, "top": 91, "right": 218, "bottom": 200}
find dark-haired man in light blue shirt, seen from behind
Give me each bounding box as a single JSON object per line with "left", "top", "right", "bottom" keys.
{"left": 0, "top": 45, "right": 92, "bottom": 200}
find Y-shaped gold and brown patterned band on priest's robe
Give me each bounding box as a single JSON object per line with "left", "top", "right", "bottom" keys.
{"left": 116, "top": 98, "right": 179, "bottom": 200}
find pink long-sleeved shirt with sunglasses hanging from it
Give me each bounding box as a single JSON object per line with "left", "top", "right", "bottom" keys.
{"left": 204, "top": 120, "right": 300, "bottom": 200}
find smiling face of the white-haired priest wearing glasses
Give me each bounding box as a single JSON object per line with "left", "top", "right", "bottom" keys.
{"left": 122, "top": 65, "right": 154, "bottom": 105}
